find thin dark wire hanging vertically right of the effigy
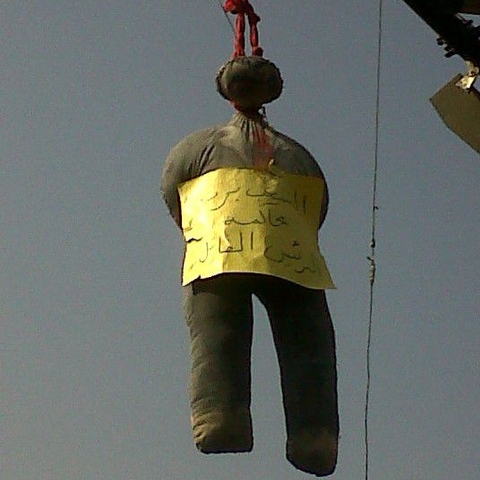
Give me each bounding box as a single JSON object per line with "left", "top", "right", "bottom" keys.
{"left": 365, "top": 0, "right": 383, "bottom": 480}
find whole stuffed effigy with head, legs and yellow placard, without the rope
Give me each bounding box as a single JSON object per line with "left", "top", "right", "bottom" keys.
{"left": 162, "top": 56, "right": 339, "bottom": 476}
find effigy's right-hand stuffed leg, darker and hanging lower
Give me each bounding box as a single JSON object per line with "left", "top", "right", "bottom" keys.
{"left": 259, "top": 280, "right": 339, "bottom": 476}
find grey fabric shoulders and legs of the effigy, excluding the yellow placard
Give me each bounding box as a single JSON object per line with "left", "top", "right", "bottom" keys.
{"left": 162, "top": 114, "right": 339, "bottom": 476}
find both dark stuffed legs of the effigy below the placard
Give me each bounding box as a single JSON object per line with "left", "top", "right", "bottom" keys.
{"left": 184, "top": 274, "right": 339, "bottom": 475}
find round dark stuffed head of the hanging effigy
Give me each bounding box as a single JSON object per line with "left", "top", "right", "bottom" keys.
{"left": 216, "top": 55, "right": 283, "bottom": 111}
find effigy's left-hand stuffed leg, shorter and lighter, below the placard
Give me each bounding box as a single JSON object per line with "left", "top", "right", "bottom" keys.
{"left": 184, "top": 274, "right": 253, "bottom": 453}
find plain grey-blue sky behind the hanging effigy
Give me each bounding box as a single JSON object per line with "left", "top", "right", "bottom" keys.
{"left": 0, "top": 0, "right": 480, "bottom": 480}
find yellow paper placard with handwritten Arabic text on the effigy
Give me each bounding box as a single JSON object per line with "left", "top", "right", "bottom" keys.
{"left": 178, "top": 168, "right": 335, "bottom": 289}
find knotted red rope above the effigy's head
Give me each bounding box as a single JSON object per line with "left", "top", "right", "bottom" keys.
{"left": 223, "top": 0, "right": 263, "bottom": 58}
